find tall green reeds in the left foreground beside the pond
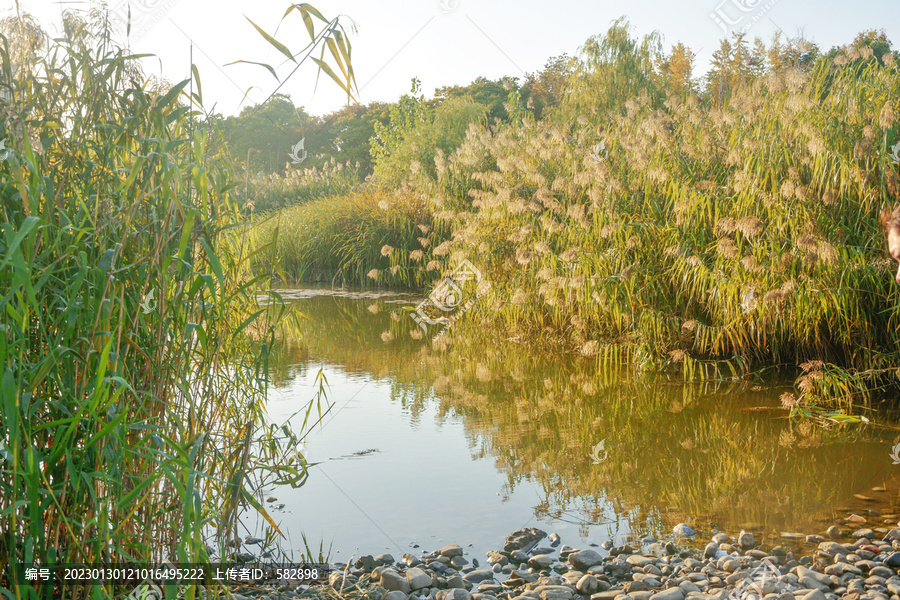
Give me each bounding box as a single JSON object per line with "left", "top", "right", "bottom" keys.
{"left": 0, "top": 14, "right": 305, "bottom": 598}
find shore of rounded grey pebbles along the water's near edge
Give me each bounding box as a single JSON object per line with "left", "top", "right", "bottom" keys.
{"left": 214, "top": 523, "right": 900, "bottom": 600}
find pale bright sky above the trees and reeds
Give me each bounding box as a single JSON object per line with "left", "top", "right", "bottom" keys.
{"left": 7, "top": 0, "right": 900, "bottom": 115}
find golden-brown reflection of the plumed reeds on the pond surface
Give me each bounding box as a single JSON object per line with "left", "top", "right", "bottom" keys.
{"left": 260, "top": 291, "right": 900, "bottom": 549}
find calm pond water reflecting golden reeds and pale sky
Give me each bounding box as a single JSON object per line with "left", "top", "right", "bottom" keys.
{"left": 245, "top": 289, "right": 900, "bottom": 562}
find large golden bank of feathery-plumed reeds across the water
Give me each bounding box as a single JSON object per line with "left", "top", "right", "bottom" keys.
{"left": 251, "top": 35, "right": 900, "bottom": 408}
